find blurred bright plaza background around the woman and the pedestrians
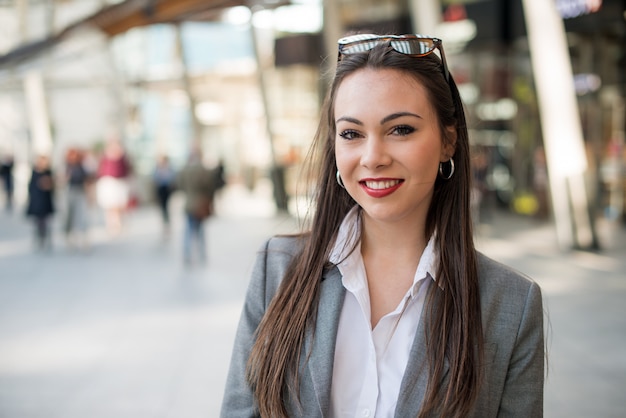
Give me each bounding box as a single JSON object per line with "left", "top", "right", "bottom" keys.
{"left": 0, "top": 0, "right": 626, "bottom": 418}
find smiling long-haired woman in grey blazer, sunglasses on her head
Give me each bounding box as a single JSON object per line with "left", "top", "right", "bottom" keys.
{"left": 222, "top": 35, "right": 544, "bottom": 418}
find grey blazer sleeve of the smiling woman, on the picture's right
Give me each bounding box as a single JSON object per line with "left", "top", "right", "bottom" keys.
{"left": 498, "top": 282, "right": 545, "bottom": 418}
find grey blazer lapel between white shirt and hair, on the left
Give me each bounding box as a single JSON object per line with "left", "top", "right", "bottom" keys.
{"left": 304, "top": 267, "right": 345, "bottom": 416}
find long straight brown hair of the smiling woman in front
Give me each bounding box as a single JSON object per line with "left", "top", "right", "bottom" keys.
{"left": 247, "top": 44, "right": 483, "bottom": 418}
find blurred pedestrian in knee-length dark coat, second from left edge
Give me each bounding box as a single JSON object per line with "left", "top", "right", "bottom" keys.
{"left": 26, "top": 155, "right": 55, "bottom": 250}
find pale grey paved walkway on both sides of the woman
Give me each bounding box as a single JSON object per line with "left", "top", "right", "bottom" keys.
{"left": 0, "top": 189, "right": 626, "bottom": 418}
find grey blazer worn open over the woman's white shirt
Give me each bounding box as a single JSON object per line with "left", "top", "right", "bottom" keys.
{"left": 221, "top": 237, "right": 544, "bottom": 418}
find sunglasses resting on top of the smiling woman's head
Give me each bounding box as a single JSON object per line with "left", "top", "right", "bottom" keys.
{"left": 337, "top": 33, "right": 450, "bottom": 81}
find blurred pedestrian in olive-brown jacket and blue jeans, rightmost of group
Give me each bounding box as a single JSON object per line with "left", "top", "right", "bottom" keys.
{"left": 175, "top": 148, "right": 215, "bottom": 265}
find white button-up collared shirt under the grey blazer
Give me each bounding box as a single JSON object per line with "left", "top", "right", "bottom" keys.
{"left": 330, "top": 207, "right": 436, "bottom": 418}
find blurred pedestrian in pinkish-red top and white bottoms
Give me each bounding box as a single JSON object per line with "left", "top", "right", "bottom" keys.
{"left": 96, "top": 139, "right": 131, "bottom": 235}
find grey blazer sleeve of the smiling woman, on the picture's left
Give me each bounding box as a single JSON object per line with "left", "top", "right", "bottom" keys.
{"left": 220, "top": 238, "right": 294, "bottom": 418}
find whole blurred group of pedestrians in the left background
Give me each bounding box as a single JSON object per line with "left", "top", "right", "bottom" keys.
{"left": 0, "top": 138, "right": 225, "bottom": 264}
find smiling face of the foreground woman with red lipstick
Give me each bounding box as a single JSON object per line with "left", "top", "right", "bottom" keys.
{"left": 334, "top": 69, "right": 454, "bottom": 222}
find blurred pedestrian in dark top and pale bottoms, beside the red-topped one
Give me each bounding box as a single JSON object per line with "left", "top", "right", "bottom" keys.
{"left": 63, "top": 148, "right": 91, "bottom": 249}
